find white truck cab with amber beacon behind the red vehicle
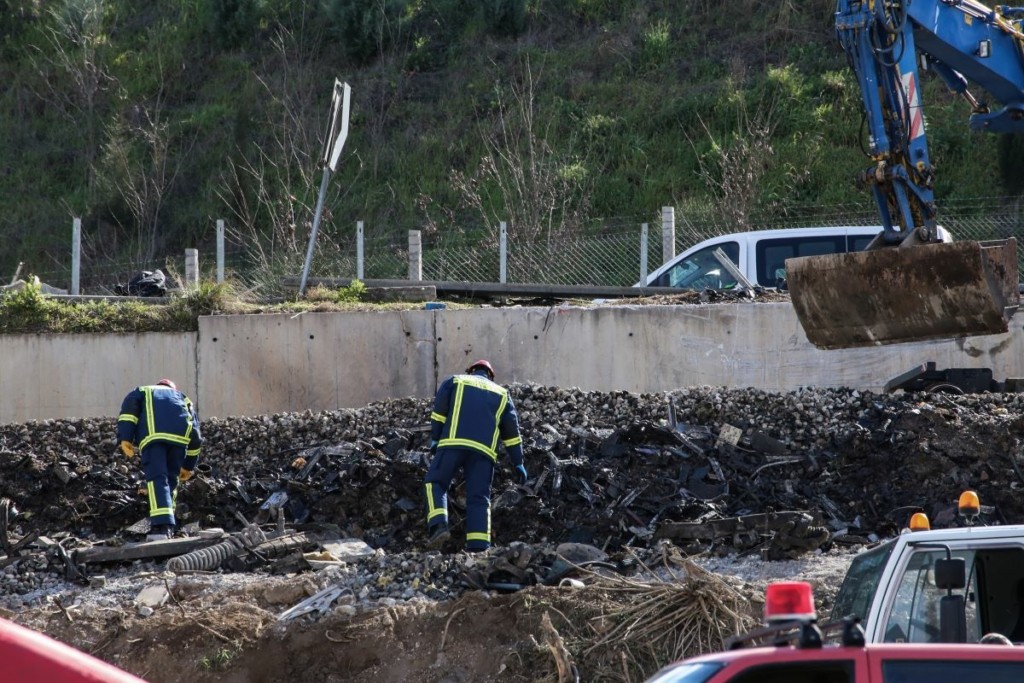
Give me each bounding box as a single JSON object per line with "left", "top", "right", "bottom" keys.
{"left": 831, "top": 492, "right": 1024, "bottom": 643}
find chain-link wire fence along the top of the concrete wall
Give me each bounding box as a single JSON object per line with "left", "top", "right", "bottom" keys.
{"left": 16, "top": 198, "right": 1024, "bottom": 294}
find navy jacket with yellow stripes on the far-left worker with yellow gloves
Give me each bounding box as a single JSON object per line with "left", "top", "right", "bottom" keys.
{"left": 118, "top": 384, "right": 203, "bottom": 470}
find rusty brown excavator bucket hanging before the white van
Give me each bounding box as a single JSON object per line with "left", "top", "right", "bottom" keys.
{"left": 785, "top": 238, "right": 1020, "bottom": 348}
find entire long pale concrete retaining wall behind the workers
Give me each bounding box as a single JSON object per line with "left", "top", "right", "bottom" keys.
{"left": 0, "top": 303, "right": 1024, "bottom": 423}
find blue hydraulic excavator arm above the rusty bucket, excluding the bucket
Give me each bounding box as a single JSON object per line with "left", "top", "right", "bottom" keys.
{"left": 836, "top": 0, "right": 1024, "bottom": 247}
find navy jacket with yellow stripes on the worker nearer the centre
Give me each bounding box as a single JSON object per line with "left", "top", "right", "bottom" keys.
{"left": 430, "top": 375, "right": 522, "bottom": 465}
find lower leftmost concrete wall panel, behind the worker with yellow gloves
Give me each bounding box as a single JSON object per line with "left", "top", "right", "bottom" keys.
{"left": 0, "top": 333, "right": 197, "bottom": 423}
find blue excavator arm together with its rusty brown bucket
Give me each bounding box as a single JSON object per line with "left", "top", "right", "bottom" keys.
{"left": 786, "top": 0, "right": 1024, "bottom": 348}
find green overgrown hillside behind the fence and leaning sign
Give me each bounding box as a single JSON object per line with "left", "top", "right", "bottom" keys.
{"left": 0, "top": 0, "right": 1022, "bottom": 294}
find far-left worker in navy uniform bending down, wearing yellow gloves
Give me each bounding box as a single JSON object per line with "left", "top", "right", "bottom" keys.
{"left": 118, "top": 379, "right": 203, "bottom": 541}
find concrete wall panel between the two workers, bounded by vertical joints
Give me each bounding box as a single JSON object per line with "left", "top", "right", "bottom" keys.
{"left": 199, "top": 311, "right": 434, "bottom": 416}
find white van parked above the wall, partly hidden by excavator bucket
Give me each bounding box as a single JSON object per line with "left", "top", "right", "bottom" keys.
{"left": 634, "top": 225, "right": 952, "bottom": 290}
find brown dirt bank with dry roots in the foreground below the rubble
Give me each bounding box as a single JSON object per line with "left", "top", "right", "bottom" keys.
{"left": 16, "top": 556, "right": 770, "bottom": 683}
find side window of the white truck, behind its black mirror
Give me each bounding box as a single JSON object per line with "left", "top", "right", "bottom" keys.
{"left": 885, "top": 550, "right": 981, "bottom": 643}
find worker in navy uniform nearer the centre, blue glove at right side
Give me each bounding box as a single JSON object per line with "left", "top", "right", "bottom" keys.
{"left": 425, "top": 360, "right": 526, "bottom": 552}
